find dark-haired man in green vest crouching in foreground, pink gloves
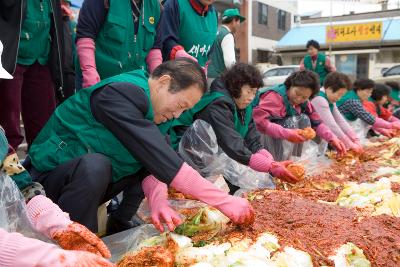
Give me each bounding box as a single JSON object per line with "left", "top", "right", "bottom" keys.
{"left": 28, "top": 59, "right": 252, "bottom": 236}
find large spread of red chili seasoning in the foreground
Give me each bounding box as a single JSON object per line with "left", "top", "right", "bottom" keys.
{"left": 240, "top": 191, "right": 400, "bottom": 267}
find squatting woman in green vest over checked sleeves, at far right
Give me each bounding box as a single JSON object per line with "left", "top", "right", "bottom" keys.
{"left": 336, "top": 79, "right": 397, "bottom": 143}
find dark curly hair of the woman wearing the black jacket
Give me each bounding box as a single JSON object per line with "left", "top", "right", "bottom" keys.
{"left": 221, "top": 63, "right": 264, "bottom": 98}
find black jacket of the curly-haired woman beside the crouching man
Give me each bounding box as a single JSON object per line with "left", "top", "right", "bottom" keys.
{"left": 194, "top": 78, "right": 263, "bottom": 165}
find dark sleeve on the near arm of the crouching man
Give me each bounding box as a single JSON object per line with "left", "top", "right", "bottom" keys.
{"left": 90, "top": 82, "right": 183, "bottom": 184}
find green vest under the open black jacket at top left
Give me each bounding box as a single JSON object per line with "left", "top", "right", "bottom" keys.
{"left": 17, "top": 0, "right": 51, "bottom": 66}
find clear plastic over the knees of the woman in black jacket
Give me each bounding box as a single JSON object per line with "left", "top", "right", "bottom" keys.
{"left": 178, "top": 120, "right": 275, "bottom": 192}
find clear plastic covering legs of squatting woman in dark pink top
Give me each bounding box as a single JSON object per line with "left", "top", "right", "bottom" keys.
{"left": 261, "top": 114, "right": 324, "bottom": 161}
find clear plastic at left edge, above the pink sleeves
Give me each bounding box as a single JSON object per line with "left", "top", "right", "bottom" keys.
{"left": 0, "top": 172, "right": 48, "bottom": 241}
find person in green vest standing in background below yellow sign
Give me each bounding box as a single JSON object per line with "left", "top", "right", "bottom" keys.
{"left": 300, "top": 40, "right": 336, "bottom": 86}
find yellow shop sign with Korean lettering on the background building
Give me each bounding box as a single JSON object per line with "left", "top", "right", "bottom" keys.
{"left": 326, "top": 22, "right": 382, "bottom": 43}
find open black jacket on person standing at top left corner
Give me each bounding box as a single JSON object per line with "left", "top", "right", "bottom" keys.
{"left": 0, "top": 0, "right": 64, "bottom": 102}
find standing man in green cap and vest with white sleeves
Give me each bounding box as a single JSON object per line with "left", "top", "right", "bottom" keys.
{"left": 207, "top": 8, "right": 246, "bottom": 86}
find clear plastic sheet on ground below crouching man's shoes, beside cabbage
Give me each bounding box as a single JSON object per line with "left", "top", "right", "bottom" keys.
{"left": 103, "top": 224, "right": 160, "bottom": 262}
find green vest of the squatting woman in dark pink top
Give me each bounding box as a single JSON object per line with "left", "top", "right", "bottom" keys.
{"left": 253, "top": 84, "right": 308, "bottom": 117}
